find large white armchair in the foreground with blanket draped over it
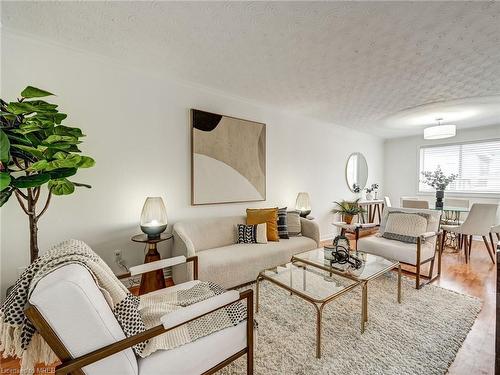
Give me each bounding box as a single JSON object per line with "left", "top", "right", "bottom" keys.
{"left": 26, "top": 256, "right": 253, "bottom": 375}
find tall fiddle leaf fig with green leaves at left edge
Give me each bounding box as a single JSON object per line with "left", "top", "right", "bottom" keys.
{"left": 0, "top": 86, "right": 95, "bottom": 262}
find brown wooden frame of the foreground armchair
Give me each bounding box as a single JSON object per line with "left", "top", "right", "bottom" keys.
{"left": 25, "top": 256, "right": 254, "bottom": 375}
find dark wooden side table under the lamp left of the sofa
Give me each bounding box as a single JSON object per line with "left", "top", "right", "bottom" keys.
{"left": 132, "top": 233, "right": 173, "bottom": 295}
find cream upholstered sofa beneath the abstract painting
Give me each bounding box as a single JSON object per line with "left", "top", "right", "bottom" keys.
{"left": 172, "top": 216, "right": 319, "bottom": 289}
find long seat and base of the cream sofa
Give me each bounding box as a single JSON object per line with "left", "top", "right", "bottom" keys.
{"left": 197, "top": 236, "right": 317, "bottom": 288}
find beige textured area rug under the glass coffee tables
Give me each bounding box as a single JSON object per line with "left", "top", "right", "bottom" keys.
{"left": 219, "top": 273, "right": 481, "bottom": 375}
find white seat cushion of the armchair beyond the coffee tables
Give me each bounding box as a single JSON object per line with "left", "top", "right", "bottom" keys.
{"left": 358, "top": 235, "right": 434, "bottom": 265}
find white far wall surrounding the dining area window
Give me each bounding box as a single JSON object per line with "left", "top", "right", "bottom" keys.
{"left": 384, "top": 125, "right": 500, "bottom": 206}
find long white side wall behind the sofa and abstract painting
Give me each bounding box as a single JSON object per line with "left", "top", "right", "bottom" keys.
{"left": 0, "top": 30, "right": 383, "bottom": 296}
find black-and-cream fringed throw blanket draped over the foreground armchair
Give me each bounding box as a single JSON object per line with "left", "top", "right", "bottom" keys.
{"left": 0, "top": 240, "right": 246, "bottom": 373}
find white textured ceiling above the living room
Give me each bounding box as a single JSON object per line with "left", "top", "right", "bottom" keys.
{"left": 2, "top": 1, "right": 500, "bottom": 137}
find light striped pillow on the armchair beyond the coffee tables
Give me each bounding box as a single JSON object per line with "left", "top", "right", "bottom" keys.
{"left": 382, "top": 211, "right": 429, "bottom": 243}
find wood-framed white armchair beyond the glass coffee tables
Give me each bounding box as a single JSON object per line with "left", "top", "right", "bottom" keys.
{"left": 358, "top": 207, "right": 442, "bottom": 289}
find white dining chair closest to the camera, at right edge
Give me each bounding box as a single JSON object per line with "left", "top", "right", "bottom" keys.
{"left": 441, "top": 203, "right": 498, "bottom": 263}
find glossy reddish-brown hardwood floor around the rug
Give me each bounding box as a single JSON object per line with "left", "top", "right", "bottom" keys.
{"left": 0, "top": 241, "right": 496, "bottom": 375}
